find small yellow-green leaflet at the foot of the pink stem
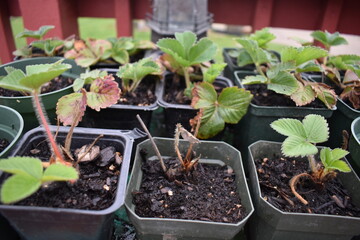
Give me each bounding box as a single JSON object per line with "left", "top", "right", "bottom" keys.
{"left": 41, "top": 164, "right": 79, "bottom": 182}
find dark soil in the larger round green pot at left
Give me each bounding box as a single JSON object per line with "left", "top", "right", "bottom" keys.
{"left": 0, "top": 76, "right": 74, "bottom": 97}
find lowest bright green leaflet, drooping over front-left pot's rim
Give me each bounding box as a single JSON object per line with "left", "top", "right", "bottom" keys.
{"left": 1, "top": 174, "right": 41, "bottom": 204}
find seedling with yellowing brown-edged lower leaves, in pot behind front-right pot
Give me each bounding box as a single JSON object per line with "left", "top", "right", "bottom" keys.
{"left": 240, "top": 39, "right": 336, "bottom": 109}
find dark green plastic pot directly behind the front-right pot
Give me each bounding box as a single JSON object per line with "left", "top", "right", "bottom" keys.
{"left": 234, "top": 71, "right": 334, "bottom": 164}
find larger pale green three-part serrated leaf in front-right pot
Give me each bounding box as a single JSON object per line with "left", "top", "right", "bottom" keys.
{"left": 270, "top": 114, "right": 329, "bottom": 157}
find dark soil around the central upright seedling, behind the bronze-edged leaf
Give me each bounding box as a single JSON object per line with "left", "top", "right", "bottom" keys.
{"left": 164, "top": 74, "right": 224, "bottom": 105}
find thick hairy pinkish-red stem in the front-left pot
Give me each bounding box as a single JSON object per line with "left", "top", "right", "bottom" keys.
{"left": 32, "top": 90, "right": 68, "bottom": 165}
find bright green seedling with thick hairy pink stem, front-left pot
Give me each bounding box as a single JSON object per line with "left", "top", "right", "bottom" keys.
{"left": 0, "top": 60, "right": 78, "bottom": 203}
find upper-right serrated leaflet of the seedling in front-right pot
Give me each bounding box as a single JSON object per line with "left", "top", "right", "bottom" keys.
{"left": 302, "top": 114, "right": 329, "bottom": 143}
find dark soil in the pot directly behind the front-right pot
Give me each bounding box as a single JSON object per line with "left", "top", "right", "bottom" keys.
{"left": 245, "top": 84, "right": 326, "bottom": 108}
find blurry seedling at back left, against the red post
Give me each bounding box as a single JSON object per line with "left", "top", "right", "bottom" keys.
{"left": 13, "top": 25, "right": 74, "bottom": 57}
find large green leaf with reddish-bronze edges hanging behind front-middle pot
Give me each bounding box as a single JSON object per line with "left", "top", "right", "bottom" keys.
{"left": 191, "top": 82, "right": 252, "bottom": 139}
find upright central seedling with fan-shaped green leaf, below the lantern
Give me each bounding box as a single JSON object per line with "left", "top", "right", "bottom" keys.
{"left": 157, "top": 31, "right": 217, "bottom": 97}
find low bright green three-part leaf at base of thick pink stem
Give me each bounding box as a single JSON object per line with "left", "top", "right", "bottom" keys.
{"left": 0, "top": 157, "right": 78, "bottom": 204}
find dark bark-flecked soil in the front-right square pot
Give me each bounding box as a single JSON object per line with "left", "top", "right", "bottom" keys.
{"left": 255, "top": 155, "right": 360, "bottom": 217}
